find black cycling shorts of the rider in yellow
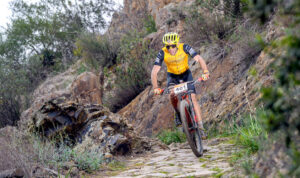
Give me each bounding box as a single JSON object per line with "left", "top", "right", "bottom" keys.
{"left": 167, "top": 69, "right": 196, "bottom": 93}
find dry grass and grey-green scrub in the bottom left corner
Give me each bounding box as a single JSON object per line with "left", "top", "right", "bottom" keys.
{"left": 0, "top": 127, "right": 103, "bottom": 177}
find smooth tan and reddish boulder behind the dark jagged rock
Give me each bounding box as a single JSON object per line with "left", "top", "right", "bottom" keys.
{"left": 19, "top": 60, "right": 102, "bottom": 129}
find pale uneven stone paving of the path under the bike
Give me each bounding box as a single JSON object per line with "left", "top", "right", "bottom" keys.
{"left": 100, "top": 138, "right": 240, "bottom": 178}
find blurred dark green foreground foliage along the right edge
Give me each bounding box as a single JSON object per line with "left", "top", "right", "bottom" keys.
{"left": 244, "top": 0, "right": 300, "bottom": 177}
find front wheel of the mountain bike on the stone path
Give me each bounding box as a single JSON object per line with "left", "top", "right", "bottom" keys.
{"left": 180, "top": 100, "right": 203, "bottom": 157}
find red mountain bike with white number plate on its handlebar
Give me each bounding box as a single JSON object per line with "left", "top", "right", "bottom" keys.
{"left": 161, "top": 78, "right": 203, "bottom": 157}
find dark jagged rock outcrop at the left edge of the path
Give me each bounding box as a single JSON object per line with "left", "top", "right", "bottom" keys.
{"left": 28, "top": 97, "right": 164, "bottom": 155}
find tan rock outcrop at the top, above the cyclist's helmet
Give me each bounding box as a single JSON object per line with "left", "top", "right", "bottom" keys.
{"left": 106, "top": 0, "right": 194, "bottom": 49}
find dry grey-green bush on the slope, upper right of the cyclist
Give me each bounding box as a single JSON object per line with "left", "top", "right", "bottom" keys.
{"left": 185, "top": 0, "right": 263, "bottom": 61}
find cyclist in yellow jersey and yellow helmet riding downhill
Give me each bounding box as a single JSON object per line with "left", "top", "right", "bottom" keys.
{"left": 151, "top": 32, "right": 209, "bottom": 139}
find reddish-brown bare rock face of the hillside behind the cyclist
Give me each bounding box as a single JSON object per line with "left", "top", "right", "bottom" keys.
{"left": 112, "top": 0, "right": 281, "bottom": 136}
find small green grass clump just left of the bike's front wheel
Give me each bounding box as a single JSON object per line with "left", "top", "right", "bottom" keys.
{"left": 157, "top": 129, "right": 186, "bottom": 145}
